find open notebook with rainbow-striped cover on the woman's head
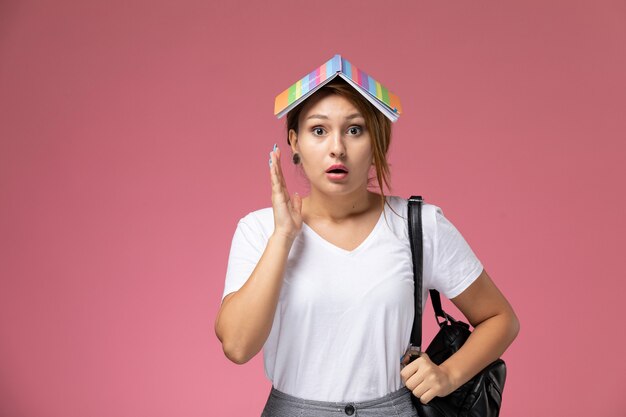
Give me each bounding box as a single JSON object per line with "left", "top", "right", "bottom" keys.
{"left": 274, "top": 54, "right": 402, "bottom": 122}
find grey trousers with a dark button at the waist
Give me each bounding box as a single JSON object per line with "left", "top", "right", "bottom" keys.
{"left": 261, "top": 386, "right": 417, "bottom": 417}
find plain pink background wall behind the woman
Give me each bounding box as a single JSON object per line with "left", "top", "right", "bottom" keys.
{"left": 0, "top": 0, "right": 626, "bottom": 417}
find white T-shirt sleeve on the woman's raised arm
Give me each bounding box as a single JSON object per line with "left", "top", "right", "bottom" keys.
{"left": 222, "top": 214, "right": 267, "bottom": 301}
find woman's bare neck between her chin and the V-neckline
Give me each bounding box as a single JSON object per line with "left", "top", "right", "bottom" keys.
{"left": 302, "top": 189, "right": 380, "bottom": 223}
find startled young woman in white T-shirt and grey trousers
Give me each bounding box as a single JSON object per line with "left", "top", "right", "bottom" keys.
{"left": 215, "top": 73, "right": 519, "bottom": 417}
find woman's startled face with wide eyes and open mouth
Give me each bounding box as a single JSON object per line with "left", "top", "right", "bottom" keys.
{"left": 289, "top": 94, "right": 372, "bottom": 194}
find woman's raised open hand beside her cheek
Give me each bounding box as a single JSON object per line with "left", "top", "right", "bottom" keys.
{"left": 270, "top": 145, "right": 302, "bottom": 241}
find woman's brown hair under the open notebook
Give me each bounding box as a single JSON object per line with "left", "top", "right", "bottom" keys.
{"left": 285, "top": 77, "right": 391, "bottom": 217}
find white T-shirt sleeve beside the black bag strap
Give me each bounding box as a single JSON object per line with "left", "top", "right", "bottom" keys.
{"left": 432, "top": 207, "right": 483, "bottom": 299}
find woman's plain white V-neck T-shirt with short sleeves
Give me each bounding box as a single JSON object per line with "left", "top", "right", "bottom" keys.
{"left": 222, "top": 196, "right": 483, "bottom": 402}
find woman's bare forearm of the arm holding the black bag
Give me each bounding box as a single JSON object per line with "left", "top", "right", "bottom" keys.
{"left": 440, "top": 311, "right": 520, "bottom": 389}
